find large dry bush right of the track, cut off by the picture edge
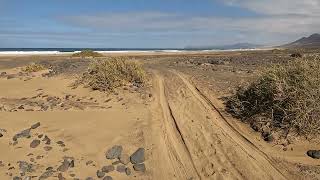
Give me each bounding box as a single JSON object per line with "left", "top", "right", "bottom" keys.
{"left": 227, "top": 56, "right": 320, "bottom": 137}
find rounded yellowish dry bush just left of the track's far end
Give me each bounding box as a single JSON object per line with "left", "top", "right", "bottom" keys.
{"left": 75, "top": 57, "right": 146, "bottom": 91}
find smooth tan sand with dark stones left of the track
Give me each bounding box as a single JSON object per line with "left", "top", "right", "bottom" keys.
{"left": 0, "top": 69, "right": 150, "bottom": 180}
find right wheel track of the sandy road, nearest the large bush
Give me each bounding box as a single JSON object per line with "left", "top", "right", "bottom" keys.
{"left": 169, "top": 71, "right": 286, "bottom": 179}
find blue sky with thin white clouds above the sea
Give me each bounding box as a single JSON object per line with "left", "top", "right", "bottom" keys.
{"left": 0, "top": 0, "right": 320, "bottom": 48}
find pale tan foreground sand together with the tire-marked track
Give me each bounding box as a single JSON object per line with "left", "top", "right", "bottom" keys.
{"left": 0, "top": 55, "right": 318, "bottom": 180}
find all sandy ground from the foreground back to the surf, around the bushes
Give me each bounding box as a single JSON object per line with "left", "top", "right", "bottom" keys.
{"left": 0, "top": 52, "right": 319, "bottom": 179}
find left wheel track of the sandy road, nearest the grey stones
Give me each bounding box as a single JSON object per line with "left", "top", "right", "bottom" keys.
{"left": 149, "top": 73, "right": 200, "bottom": 180}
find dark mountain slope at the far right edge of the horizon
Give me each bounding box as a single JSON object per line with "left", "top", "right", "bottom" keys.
{"left": 280, "top": 33, "right": 320, "bottom": 48}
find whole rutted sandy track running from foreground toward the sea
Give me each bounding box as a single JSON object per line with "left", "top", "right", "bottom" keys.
{"left": 155, "top": 71, "right": 285, "bottom": 179}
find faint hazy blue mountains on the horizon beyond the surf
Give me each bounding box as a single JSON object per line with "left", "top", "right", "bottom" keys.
{"left": 185, "top": 43, "right": 263, "bottom": 50}
